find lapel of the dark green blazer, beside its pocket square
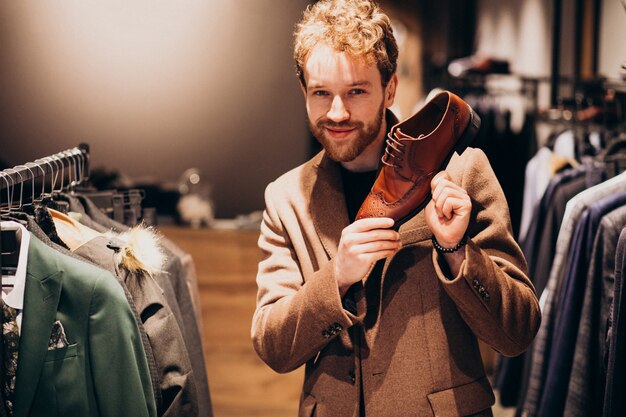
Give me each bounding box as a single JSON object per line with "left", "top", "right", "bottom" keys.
{"left": 14, "top": 235, "right": 63, "bottom": 417}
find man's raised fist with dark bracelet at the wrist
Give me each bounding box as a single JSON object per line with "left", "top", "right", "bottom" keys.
{"left": 424, "top": 171, "right": 472, "bottom": 276}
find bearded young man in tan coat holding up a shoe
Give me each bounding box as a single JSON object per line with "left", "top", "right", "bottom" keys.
{"left": 252, "top": 0, "right": 540, "bottom": 417}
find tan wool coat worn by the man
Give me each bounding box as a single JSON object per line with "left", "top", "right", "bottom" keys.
{"left": 252, "top": 148, "right": 541, "bottom": 417}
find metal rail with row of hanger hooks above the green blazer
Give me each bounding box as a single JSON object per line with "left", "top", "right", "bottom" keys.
{"left": 0, "top": 143, "right": 89, "bottom": 207}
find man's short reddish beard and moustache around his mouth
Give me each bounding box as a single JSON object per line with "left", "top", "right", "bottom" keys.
{"left": 309, "top": 102, "right": 385, "bottom": 162}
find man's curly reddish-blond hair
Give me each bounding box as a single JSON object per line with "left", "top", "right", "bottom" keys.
{"left": 294, "top": 0, "right": 398, "bottom": 86}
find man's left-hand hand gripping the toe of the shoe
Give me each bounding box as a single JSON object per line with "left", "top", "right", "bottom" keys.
{"left": 335, "top": 217, "right": 402, "bottom": 297}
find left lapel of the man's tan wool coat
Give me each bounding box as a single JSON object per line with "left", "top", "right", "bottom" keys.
{"left": 305, "top": 152, "right": 349, "bottom": 258}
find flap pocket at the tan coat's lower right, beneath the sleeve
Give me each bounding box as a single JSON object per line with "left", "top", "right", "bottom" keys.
{"left": 428, "top": 377, "right": 496, "bottom": 417}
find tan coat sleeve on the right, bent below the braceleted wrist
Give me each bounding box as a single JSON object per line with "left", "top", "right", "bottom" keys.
{"left": 433, "top": 149, "right": 541, "bottom": 356}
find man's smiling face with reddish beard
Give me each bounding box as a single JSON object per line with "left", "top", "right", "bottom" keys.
{"left": 303, "top": 44, "right": 395, "bottom": 162}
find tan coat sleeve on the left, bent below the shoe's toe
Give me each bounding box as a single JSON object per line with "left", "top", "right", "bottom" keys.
{"left": 251, "top": 183, "right": 354, "bottom": 372}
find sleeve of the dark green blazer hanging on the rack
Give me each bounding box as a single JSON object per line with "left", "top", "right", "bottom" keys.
{"left": 89, "top": 274, "right": 156, "bottom": 417}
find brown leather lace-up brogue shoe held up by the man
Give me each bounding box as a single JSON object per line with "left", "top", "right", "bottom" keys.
{"left": 356, "top": 91, "right": 480, "bottom": 228}
